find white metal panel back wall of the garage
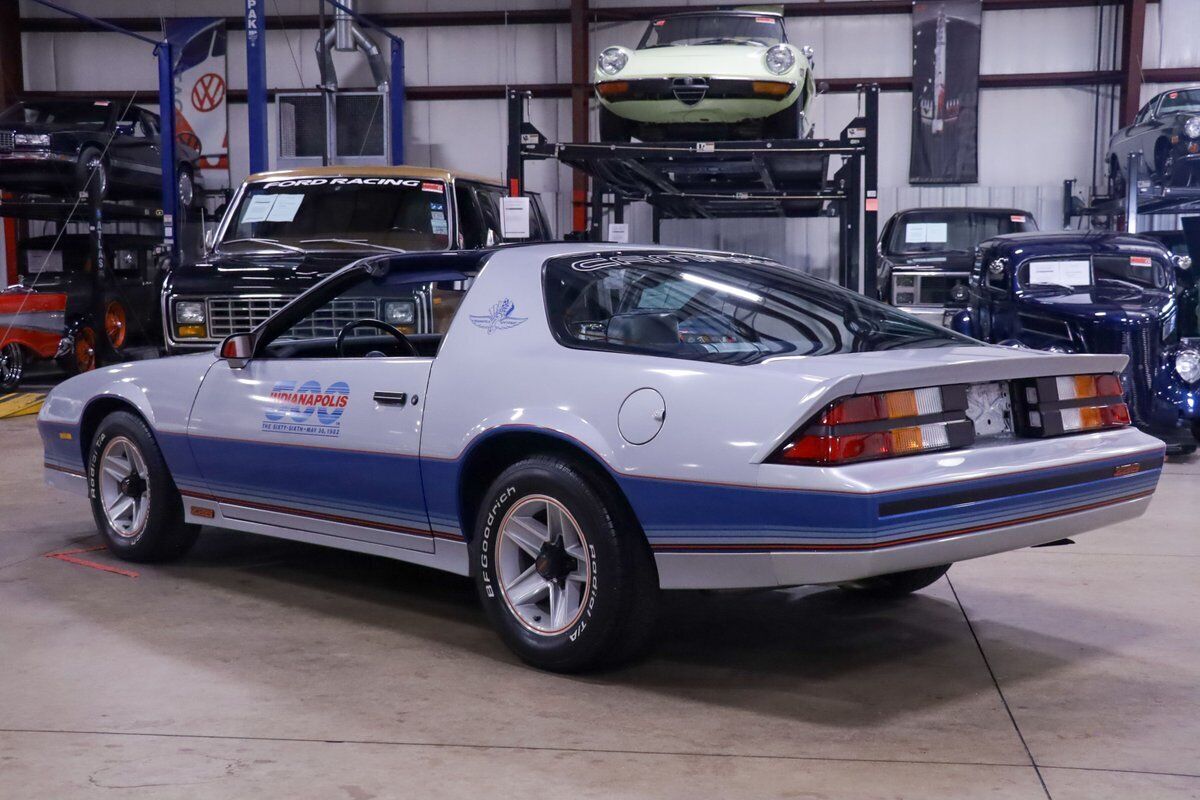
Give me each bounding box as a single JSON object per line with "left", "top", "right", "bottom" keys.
{"left": 14, "top": 0, "right": 1200, "bottom": 275}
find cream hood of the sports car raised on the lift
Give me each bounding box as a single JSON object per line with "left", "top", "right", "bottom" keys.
{"left": 601, "top": 44, "right": 808, "bottom": 80}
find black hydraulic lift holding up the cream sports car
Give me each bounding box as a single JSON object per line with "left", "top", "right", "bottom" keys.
{"left": 508, "top": 85, "right": 880, "bottom": 296}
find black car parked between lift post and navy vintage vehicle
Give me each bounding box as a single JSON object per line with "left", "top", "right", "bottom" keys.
{"left": 878, "top": 207, "right": 1038, "bottom": 325}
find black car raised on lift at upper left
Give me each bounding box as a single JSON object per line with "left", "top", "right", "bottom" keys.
{"left": 0, "top": 100, "right": 199, "bottom": 207}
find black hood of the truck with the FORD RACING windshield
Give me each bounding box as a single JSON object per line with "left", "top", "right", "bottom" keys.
{"left": 163, "top": 251, "right": 369, "bottom": 295}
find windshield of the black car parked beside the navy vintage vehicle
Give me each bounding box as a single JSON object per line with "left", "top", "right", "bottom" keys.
{"left": 887, "top": 211, "right": 1038, "bottom": 255}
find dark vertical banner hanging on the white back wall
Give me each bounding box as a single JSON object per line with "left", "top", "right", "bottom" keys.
{"left": 908, "top": 0, "right": 983, "bottom": 184}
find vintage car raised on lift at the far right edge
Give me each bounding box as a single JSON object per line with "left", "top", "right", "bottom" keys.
{"left": 1108, "top": 88, "right": 1200, "bottom": 197}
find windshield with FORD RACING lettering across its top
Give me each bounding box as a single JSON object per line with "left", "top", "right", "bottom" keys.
{"left": 218, "top": 178, "right": 450, "bottom": 251}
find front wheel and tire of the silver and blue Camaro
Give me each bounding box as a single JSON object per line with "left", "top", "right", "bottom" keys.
{"left": 88, "top": 411, "right": 199, "bottom": 561}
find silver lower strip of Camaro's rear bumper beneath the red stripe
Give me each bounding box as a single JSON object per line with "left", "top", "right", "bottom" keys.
{"left": 654, "top": 489, "right": 1153, "bottom": 589}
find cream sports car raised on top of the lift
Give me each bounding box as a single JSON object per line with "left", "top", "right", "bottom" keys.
{"left": 595, "top": 11, "right": 816, "bottom": 142}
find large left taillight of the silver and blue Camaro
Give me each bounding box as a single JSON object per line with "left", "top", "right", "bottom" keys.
{"left": 768, "top": 386, "right": 974, "bottom": 464}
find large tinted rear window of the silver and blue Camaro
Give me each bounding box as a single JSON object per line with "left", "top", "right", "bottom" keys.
{"left": 545, "top": 251, "right": 971, "bottom": 365}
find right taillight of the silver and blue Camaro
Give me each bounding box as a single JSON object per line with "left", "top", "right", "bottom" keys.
{"left": 1014, "top": 374, "right": 1129, "bottom": 437}
